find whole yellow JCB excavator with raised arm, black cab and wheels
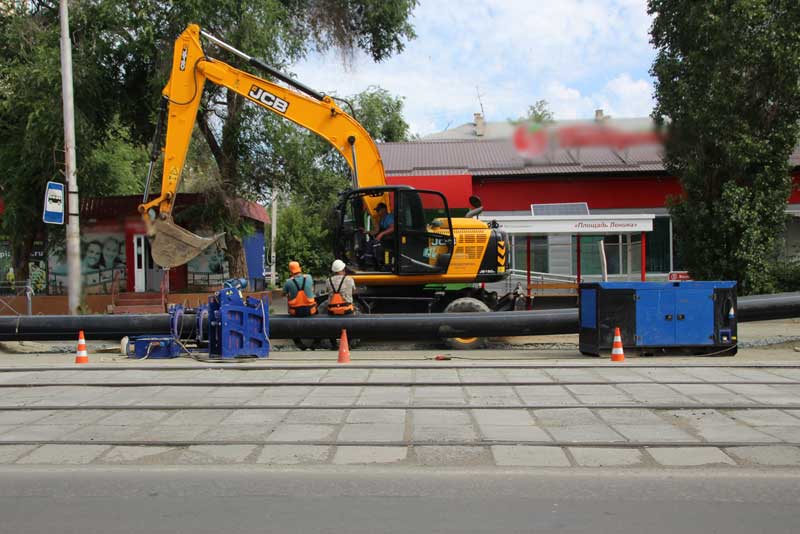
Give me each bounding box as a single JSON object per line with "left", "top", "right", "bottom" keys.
{"left": 139, "top": 25, "right": 520, "bottom": 348}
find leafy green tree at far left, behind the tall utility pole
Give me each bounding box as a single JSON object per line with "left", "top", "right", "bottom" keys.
{"left": 0, "top": 2, "right": 146, "bottom": 279}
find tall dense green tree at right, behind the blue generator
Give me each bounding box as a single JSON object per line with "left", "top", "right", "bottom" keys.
{"left": 648, "top": 0, "right": 800, "bottom": 293}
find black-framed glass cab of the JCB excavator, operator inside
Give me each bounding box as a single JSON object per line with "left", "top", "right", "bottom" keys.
{"left": 334, "top": 186, "right": 455, "bottom": 276}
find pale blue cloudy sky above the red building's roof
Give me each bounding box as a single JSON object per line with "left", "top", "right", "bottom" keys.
{"left": 291, "top": 0, "right": 655, "bottom": 135}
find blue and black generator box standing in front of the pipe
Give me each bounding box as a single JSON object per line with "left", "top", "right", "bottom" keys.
{"left": 579, "top": 281, "right": 738, "bottom": 355}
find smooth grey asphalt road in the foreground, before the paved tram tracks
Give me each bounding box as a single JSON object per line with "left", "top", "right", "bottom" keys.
{"left": 0, "top": 467, "right": 800, "bottom": 534}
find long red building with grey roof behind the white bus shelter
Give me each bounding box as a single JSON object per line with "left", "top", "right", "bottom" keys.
{"left": 379, "top": 114, "right": 800, "bottom": 278}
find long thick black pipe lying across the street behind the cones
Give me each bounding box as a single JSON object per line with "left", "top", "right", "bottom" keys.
{"left": 0, "top": 292, "right": 800, "bottom": 341}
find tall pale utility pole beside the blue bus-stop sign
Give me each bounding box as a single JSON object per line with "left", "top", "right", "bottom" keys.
{"left": 59, "top": 0, "right": 81, "bottom": 315}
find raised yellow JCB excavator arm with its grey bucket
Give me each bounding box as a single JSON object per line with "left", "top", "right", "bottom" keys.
{"left": 139, "top": 24, "right": 386, "bottom": 268}
